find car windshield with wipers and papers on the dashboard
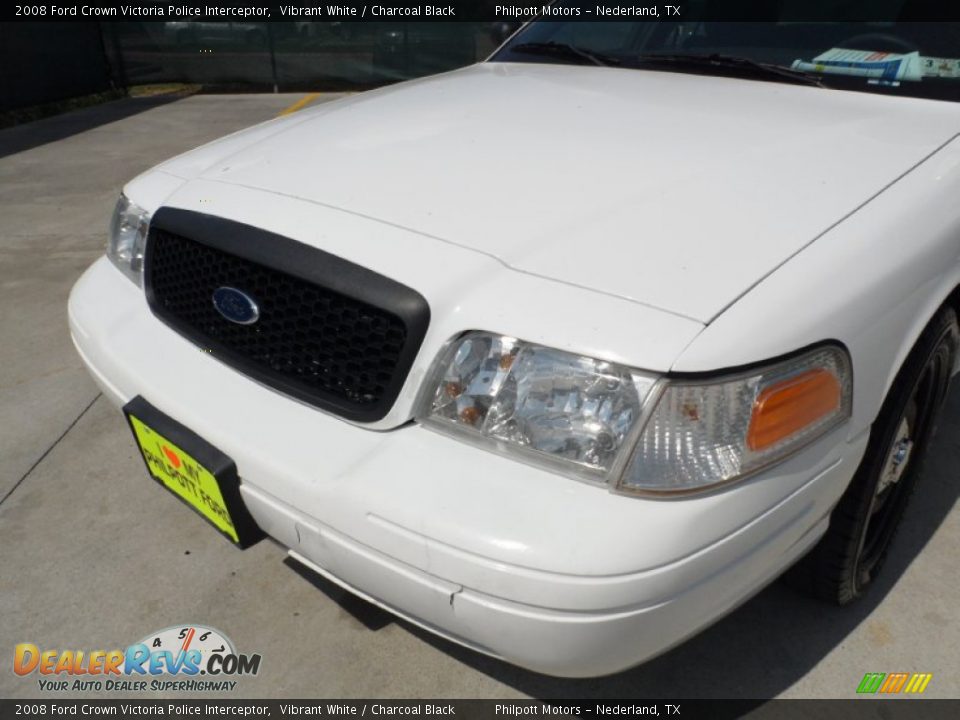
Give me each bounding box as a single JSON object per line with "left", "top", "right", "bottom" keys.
{"left": 491, "top": 0, "right": 960, "bottom": 101}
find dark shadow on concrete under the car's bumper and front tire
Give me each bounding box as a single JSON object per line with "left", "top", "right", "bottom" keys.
{"left": 401, "top": 383, "right": 960, "bottom": 700}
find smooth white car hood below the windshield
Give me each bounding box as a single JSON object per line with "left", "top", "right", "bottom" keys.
{"left": 163, "top": 63, "right": 960, "bottom": 322}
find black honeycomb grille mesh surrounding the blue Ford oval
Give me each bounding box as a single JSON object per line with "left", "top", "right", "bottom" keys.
{"left": 147, "top": 230, "right": 407, "bottom": 407}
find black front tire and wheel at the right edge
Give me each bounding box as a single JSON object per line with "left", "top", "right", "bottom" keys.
{"left": 788, "top": 309, "right": 960, "bottom": 605}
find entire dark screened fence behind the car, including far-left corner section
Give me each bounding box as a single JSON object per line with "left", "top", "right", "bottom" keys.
{"left": 0, "top": 22, "right": 504, "bottom": 111}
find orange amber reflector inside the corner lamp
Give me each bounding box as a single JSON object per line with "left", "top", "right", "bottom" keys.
{"left": 747, "top": 368, "right": 842, "bottom": 452}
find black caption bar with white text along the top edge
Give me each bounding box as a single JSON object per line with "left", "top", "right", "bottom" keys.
{"left": 7, "top": 0, "right": 960, "bottom": 22}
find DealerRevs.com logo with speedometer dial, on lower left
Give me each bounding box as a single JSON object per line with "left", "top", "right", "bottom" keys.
{"left": 13, "top": 624, "right": 261, "bottom": 692}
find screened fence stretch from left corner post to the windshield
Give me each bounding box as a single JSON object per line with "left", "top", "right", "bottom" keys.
{"left": 106, "top": 22, "right": 497, "bottom": 91}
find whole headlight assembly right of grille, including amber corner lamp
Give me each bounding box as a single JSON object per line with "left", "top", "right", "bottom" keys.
{"left": 418, "top": 332, "right": 852, "bottom": 495}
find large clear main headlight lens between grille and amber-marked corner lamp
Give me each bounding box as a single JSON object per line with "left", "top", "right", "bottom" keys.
{"left": 419, "top": 332, "right": 655, "bottom": 481}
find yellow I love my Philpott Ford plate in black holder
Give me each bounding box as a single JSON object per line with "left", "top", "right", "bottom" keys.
{"left": 123, "top": 397, "right": 263, "bottom": 547}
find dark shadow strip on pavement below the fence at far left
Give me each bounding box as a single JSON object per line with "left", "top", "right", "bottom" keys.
{"left": 0, "top": 93, "right": 186, "bottom": 158}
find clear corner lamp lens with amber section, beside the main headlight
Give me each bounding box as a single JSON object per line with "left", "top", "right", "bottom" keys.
{"left": 618, "top": 346, "right": 852, "bottom": 493}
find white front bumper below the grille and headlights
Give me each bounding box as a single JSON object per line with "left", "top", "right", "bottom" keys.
{"left": 69, "top": 259, "right": 866, "bottom": 676}
